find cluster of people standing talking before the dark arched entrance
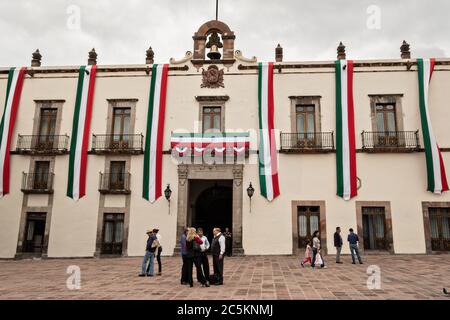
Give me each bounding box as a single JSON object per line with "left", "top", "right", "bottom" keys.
{"left": 180, "top": 228, "right": 226, "bottom": 287}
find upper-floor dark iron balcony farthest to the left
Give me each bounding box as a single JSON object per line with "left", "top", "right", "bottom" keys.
{"left": 16, "top": 134, "right": 69, "bottom": 155}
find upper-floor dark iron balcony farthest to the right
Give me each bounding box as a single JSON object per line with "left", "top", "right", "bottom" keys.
{"left": 361, "top": 130, "right": 420, "bottom": 153}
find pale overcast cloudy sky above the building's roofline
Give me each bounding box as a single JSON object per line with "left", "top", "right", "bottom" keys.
{"left": 0, "top": 0, "right": 450, "bottom": 66}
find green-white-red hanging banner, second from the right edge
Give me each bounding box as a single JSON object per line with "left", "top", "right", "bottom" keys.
{"left": 336, "top": 60, "right": 357, "bottom": 200}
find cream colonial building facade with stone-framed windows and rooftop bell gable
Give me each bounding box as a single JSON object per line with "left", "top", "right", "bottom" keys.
{"left": 0, "top": 20, "right": 450, "bottom": 258}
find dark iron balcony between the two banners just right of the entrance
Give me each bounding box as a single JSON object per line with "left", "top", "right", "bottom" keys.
{"left": 280, "top": 132, "right": 334, "bottom": 153}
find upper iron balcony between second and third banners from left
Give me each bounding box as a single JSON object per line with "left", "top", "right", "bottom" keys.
{"left": 91, "top": 134, "right": 144, "bottom": 154}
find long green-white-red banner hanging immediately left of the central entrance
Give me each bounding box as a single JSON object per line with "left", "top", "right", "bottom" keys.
{"left": 142, "top": 64, "right": 169, "bottom": 203}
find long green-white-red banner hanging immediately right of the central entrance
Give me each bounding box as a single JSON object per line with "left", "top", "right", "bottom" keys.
{"left": 258, "top": 62, "right": 280, "bottom": 201}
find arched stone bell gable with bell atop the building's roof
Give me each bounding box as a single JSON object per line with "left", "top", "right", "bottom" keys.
{"left": 192, "top": 20, "right": 236, "bottom": 68}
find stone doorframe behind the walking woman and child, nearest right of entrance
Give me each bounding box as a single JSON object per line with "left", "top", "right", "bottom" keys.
{"left": 291, "top": 200, "right": 328, "bottom": 256}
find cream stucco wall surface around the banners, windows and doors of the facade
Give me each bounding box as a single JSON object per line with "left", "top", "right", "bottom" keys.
{"left": 0, "top": 58, "right": 450, "bottom": 258}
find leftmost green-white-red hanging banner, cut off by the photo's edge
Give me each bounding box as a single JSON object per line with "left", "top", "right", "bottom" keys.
{"left": 0, "top": 67, "right": 26, "bottom": 198}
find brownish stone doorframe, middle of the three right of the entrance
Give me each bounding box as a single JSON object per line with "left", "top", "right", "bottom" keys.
{"left": 356, "top": 201, "right": 395, "bottom": 254}
